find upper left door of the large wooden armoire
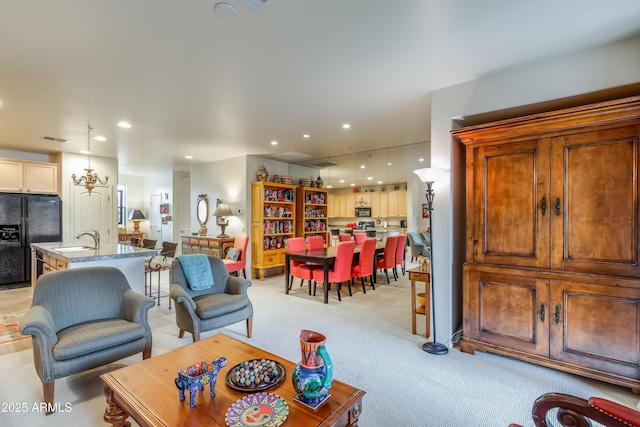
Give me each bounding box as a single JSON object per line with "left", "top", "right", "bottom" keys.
{"left": 474, "top": 140, "right": 549, "bottom": 267}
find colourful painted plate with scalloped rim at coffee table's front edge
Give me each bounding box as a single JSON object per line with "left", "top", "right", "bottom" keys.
{"left": 224, "top": 393, "right": 289, "bottom": 427}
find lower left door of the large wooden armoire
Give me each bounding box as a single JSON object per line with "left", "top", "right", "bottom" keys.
{"left": 465, "top": 271, "right": 549, "bottom": 356}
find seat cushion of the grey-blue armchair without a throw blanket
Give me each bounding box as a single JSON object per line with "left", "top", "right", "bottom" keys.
{"left": 53, "top": 319, "right": 145, "bottom": 360}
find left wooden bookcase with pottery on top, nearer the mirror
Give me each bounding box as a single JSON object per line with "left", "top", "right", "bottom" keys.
{"left": 251, "top": 182, "right": 296, "bottom": 280}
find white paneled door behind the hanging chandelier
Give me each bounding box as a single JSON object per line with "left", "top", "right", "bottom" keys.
{"left": 71, "top": 184, "right": 117, "bottom": 246}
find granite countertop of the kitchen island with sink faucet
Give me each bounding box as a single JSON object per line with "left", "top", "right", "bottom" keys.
{"left": 31, "top": 242, "right": 158, "bottom": 262}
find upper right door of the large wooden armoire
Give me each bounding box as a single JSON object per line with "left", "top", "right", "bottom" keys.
{"left": 551, "top": 126, "right": 640, "bottom": 277}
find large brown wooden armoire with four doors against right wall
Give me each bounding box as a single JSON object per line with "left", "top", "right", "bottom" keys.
{"left": 452, "top": 97, "right": 640, "bottom": 392}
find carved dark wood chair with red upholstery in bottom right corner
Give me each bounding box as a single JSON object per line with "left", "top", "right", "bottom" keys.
{"left": 509, "top": 393, "right": 640, "bottom": 427}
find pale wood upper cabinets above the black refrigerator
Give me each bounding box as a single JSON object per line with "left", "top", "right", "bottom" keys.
{"left": 0, "top": 159, "right": 59, "bottom": 194}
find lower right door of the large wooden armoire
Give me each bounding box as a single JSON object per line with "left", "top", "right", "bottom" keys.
{"left": 550, "top": 281, "right": 640, "bottom": 379}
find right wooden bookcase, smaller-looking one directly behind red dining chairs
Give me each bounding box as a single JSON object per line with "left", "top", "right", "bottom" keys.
{"left": 296, "top": 187, "right": 329, "bottom": 245}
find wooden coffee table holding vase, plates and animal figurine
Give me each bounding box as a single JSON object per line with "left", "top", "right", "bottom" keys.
{"left": 100, "top": 334, "right": 365, "bottom": 427}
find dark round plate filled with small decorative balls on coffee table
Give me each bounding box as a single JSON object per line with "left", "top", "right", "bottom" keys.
{"left": 226, "top": 359, "right": 287, "bottom": 392}
